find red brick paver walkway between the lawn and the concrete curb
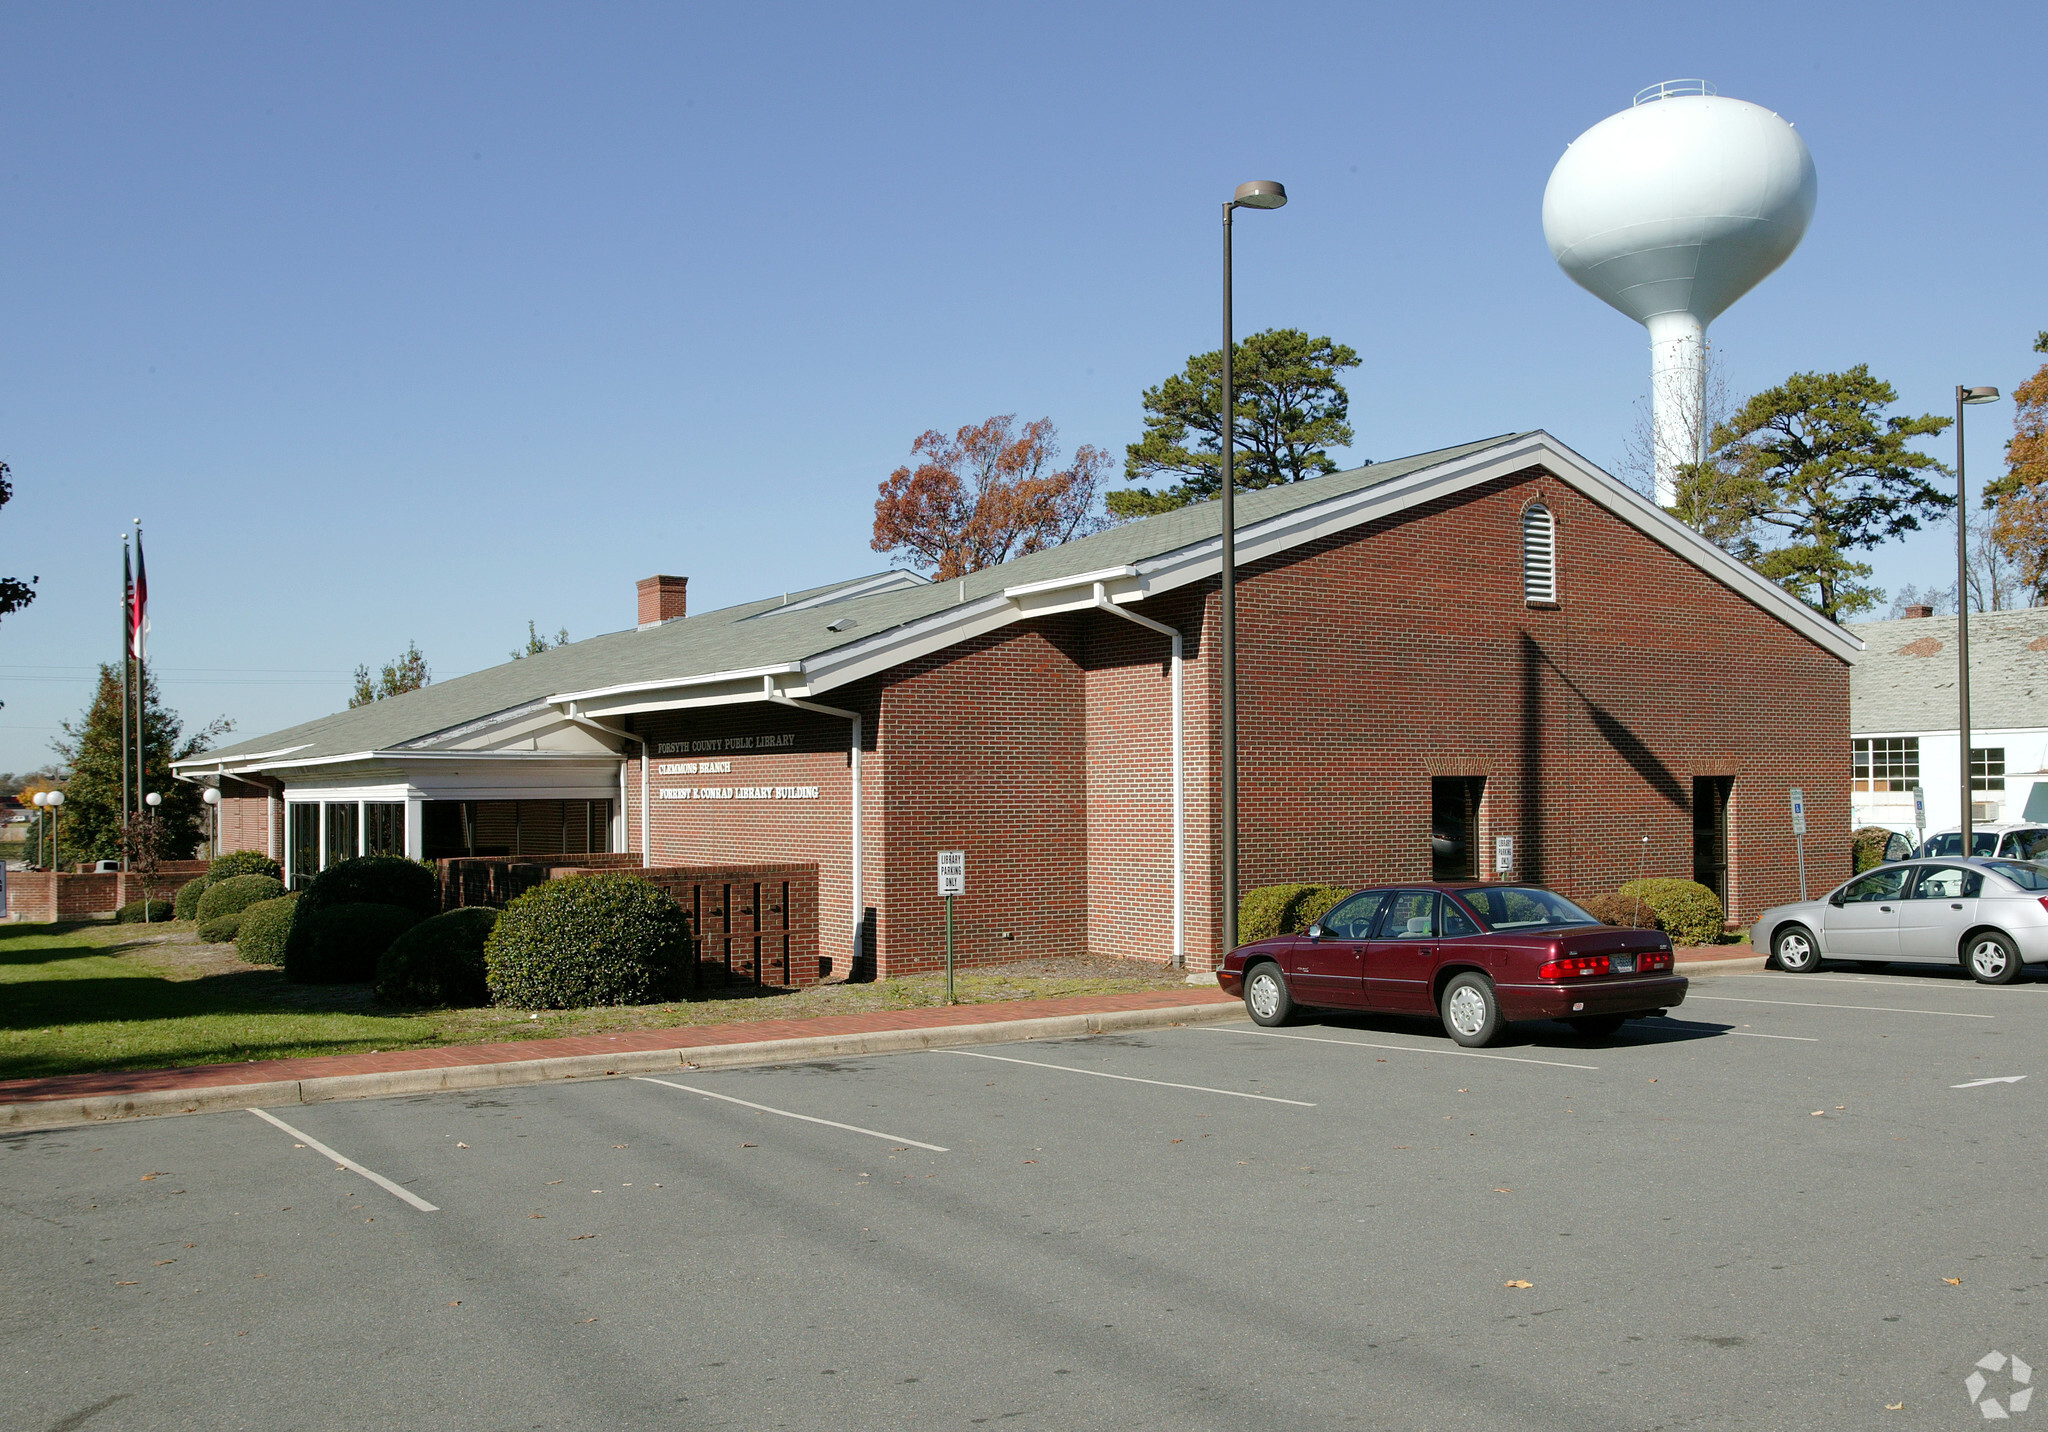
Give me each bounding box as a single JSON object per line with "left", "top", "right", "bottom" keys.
{"left": 0, "top": 985, "right": 1235, "bottom": 1104}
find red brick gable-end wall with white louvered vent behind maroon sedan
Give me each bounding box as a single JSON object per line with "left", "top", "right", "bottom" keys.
{"left": 1204, "top": 471, "right": 1849, "bottom": 938}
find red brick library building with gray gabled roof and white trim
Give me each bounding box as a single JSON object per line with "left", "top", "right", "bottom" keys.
{"left": 178, "top": 432, "right": 1862, "bottom": 973}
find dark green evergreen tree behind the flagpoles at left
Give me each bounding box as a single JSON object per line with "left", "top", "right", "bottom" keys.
{"left": 53, "top": 664, "right": 233, "bottom": 865}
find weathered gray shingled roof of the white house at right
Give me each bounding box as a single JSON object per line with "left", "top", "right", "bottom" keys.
{"left": 1849, "top": 606, "right": 2048, "bottom": 735}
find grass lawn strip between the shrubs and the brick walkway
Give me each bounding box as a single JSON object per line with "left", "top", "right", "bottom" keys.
{"left": 0, "top": 924, "right": 1184, "bottom": 1080}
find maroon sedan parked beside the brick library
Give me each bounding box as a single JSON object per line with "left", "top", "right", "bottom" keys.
{"left": 1217, "top": 881, "right": 1688, "bottom": 1047}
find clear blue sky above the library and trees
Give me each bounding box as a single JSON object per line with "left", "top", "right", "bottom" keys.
{"left": 0, "top": 2, "right": 2048, "bottom": 770}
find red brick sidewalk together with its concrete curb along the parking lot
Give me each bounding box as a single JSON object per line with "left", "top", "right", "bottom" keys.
{"left": 0, "top": 944, "right": 1763, "bottom": 1129}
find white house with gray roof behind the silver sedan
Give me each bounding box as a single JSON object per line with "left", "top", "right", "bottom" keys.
{"left": 1849, "top": 606, "right": 2048, "bottom": 836}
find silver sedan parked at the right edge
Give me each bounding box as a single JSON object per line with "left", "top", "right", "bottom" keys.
{"left": 1749, "top": 858, "right": 2048, "bottom": 985}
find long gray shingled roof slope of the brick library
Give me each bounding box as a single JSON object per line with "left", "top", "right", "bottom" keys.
{"left": 176, "top": 432, "right": 1528, "bottom": 764}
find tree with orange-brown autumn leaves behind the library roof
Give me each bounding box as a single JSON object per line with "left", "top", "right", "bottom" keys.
{"left": 872, "top": 414, "right": 1110, "bottom": 582}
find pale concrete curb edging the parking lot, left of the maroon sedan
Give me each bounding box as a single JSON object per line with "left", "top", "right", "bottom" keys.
{"left": 0, "top": 1000, "right": 1245, "bottom": 1131}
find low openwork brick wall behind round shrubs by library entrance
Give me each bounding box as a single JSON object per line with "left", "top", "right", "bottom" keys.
{"left": 436, "top": 854, "right": 831, "bottom": 987}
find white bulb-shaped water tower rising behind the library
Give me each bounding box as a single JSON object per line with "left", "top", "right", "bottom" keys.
{"left": 1542, "top": 80, "right": 1817, "bottom": 506}
